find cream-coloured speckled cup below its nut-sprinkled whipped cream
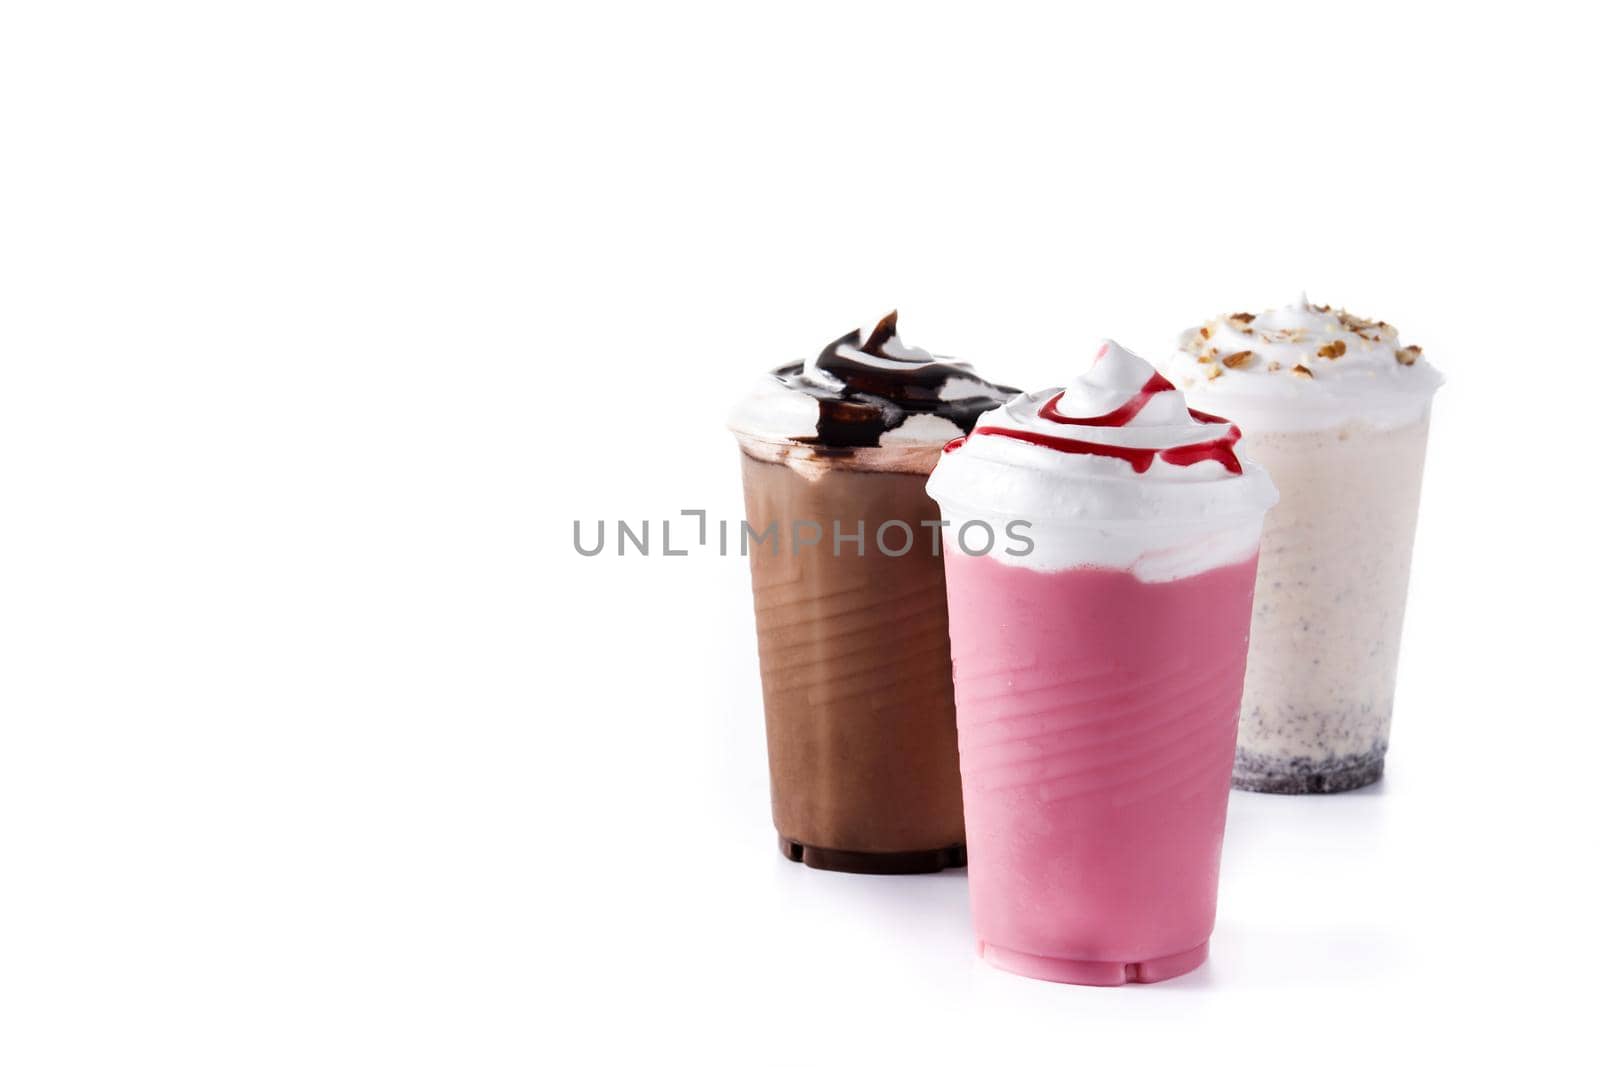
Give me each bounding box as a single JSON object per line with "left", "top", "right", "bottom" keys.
{"left": 1234, "top": 406, "right": 1429, "bottom": 793}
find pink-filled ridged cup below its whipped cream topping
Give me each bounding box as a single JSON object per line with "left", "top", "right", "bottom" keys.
{"left": 944, "top": 552, "right": 1256, "bottom": 985}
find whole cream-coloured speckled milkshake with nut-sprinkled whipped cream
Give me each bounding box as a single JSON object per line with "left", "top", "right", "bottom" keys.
{"left": 1166, "top": 298, "right": 1443, "bottom": 793}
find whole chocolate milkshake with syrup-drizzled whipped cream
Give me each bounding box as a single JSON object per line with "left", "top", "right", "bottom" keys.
{"left": 730, "top": 314, "right": 1016, "bottom": 873}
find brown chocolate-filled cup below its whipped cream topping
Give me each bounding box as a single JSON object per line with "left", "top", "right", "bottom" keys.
{"left": 738, "top": 435, "right": 966, "bottom": 873}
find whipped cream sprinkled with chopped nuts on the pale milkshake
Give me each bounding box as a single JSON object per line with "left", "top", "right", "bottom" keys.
{"left": 1166, "top": 296, "right": 1443, "bottom": 430}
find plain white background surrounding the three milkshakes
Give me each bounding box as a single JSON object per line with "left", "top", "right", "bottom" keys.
{"left": 0, "top": 3, "right": 1600, "bottom": 1064}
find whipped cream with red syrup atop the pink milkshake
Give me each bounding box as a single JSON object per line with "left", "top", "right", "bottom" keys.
{"left": 928, "top": 341, "right": 1277, "bottom": 581}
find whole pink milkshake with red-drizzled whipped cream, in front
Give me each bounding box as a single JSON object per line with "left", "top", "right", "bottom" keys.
{"left": 928, "top": 342, "right": 1277, "bottom": 985}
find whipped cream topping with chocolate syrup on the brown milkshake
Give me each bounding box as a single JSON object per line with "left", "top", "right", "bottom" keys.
{"left": 730, "top": 312, "right": 1018, "bottom": 448}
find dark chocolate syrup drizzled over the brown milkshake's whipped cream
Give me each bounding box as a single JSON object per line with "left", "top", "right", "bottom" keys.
{"left": 773, "top": 312, "right": 1018, "bottom": 448}
